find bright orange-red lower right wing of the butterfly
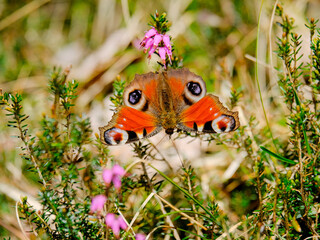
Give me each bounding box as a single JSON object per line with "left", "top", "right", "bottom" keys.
{"left": 177, "top": 94, "right": 240, "bottom": 133}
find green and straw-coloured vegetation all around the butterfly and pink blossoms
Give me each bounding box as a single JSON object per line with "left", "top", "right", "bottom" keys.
{"left": 0, "top": 0, "right": 320, "bottom": 240}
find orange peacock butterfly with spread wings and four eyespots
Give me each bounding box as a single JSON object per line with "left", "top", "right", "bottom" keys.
{"left": 99, "top": 68, "right": 240, "bottom": 145}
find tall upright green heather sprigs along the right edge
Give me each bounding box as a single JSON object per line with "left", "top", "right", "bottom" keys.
{"left": 246, "top": 4, "right": 320, "bottom": 236}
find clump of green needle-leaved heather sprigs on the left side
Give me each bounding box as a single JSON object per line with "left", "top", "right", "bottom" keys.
{"left": 1, "top": 69, "right": 105, "bottom": 239}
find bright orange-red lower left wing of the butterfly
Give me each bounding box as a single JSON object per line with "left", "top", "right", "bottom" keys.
{"left": 99, "top": 106, "right": 161, "bottom": 145}
